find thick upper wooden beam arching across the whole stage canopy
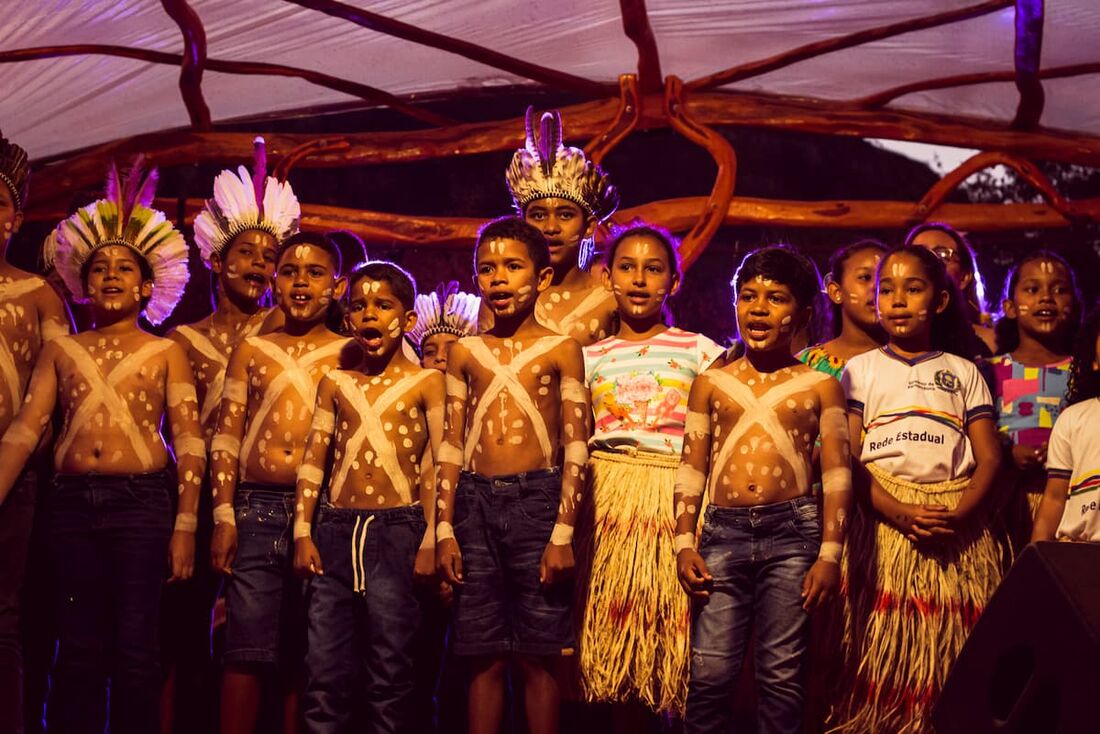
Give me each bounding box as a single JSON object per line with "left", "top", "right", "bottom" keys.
{"left": 32, "top": 94, "right": 1100, "bottom": 209}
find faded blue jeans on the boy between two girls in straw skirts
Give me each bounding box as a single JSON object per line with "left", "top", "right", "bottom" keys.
{"left": 684, "top": 497, "right": 821, "bottom": 734}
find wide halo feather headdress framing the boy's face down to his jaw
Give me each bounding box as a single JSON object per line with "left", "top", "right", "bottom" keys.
{"left": 43, "top": 155, "right": 188, "bottom": 325}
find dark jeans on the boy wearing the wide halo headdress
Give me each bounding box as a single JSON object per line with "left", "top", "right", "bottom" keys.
{"left": 47, "top": 470, "right": 175, "bottom": 734}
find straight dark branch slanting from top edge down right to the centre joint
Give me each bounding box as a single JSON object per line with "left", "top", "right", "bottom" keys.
{"left": 287, "top": 0, "right": 615, "bottom": 97}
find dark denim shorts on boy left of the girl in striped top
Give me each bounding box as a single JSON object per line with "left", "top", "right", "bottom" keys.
{"left": 454, "top": 468, "right": 574, "bottom": 656}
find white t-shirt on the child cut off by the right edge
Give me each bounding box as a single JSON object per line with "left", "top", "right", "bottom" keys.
{"left": 1046, "top": 397, "right": 1100, "bottom": 543}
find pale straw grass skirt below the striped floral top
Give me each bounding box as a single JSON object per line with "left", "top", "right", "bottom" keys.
{"left": 576, "top": 451, "right": 691, "bottom": 714}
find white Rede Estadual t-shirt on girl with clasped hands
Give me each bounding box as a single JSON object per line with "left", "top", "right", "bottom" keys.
{"left": 840, "top": 346, "right": 993, "bottom": 482}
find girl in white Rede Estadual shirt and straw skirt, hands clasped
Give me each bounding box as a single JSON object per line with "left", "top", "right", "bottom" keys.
{"left": 832, "top": 245, "right": 1001, "bottom": 734}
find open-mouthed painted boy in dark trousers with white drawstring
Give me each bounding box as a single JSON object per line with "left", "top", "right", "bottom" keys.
{"left": 294, "top": 262, "right": 444, "bottom": 732}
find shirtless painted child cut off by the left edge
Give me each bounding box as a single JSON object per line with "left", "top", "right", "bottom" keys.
{"left": 0, "top": 129, "right": 69, "bottom": 732}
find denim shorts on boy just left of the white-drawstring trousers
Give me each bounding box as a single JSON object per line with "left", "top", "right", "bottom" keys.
{"left": 223, "top": 482, "right": 306, "bottom": 669}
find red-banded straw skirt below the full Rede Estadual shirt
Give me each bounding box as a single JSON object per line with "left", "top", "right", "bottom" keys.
{"left": 828, "top": 464, "right": 1002, "bottom": 734}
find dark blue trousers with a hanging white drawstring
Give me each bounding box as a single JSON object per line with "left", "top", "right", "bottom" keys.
{"left": 301, "top": 504, "right": 428, "bottom": 733}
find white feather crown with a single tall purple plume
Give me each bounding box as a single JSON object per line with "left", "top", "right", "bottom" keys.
{"left": 195, "top": 138, "right": 301, "bottom": 265}
